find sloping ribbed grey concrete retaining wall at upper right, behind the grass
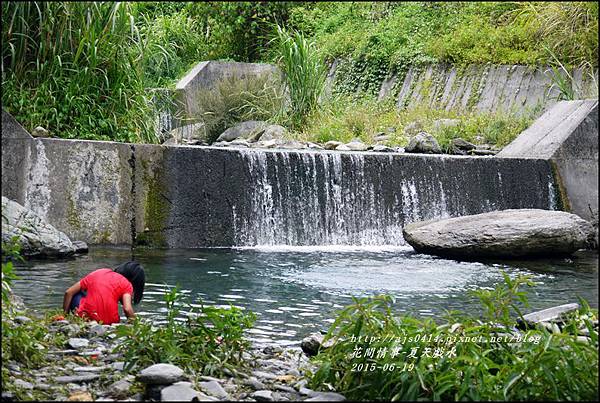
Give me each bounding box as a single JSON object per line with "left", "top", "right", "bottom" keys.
{"left": 328, "top": 60, "right": 598, "bottom": 113}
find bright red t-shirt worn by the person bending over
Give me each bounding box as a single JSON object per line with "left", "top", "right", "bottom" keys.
{"left": 77, "top": 269, "right": 133, "bottom": 325}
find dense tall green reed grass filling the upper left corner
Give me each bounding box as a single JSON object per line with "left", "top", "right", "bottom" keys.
{"left": 2, "top": 2, "right": 153, "bottom": 142}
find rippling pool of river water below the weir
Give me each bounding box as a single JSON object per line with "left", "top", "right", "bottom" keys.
{"left": 14, "top": 246, "right": 598, "bottom": 346}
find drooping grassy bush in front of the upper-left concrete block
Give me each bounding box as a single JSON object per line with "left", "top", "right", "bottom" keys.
{"left": 197, "top": 76, "right": 284, "bottom": 143}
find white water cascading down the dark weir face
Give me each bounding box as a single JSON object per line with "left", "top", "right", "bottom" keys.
{"left": 220, "top": 149, "right": 556, "bottom": 246}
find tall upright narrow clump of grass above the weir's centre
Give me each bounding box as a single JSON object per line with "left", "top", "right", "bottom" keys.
{"left": 276, "top": 26, "right": 327, "bottom": 127}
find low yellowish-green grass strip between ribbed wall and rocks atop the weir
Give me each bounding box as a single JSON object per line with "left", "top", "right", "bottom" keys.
{"left": 296, "top": 94, "right": 539, "bottom": 149}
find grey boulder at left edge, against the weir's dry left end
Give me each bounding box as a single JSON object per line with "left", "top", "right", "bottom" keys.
{"left": 2, "top": 196, "right": 77, "bottom": 257}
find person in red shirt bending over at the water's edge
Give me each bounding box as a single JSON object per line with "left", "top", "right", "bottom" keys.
{"left": 63, "top": 261, "right": 146, "bottom": 325}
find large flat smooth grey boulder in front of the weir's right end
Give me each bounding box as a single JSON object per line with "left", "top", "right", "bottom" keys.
{"left": 403, "top": 209, "right": 593, "bottom": 259}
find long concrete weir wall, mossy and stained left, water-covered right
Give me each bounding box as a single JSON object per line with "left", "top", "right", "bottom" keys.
{"left": 2, "top": 103, "right": 596, "bottom": 248}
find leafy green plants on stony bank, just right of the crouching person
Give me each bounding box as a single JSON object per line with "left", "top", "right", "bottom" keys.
{"left": 117, "top": 288, "right": 255, "bottom": 375}
